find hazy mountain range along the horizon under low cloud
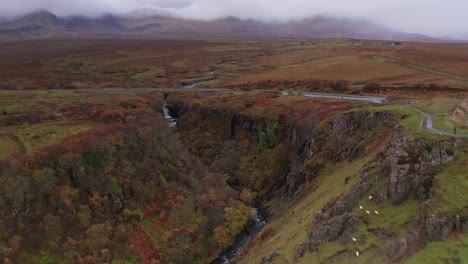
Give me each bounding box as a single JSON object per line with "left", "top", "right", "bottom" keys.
{"left": 0, "top": 9, "right": 441, "bottom": 42}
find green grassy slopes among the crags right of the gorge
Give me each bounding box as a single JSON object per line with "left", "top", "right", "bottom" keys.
{"left": 242, "top": 105, "right": 468, "bottom": 263}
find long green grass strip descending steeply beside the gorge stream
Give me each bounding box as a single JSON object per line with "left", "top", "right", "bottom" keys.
{"left": 243, "top": 154, "right": 370, "bottom": 263}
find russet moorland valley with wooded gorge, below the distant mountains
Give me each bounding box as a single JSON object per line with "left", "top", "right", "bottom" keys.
{"left": 0, "top": 37, "right": 468, "bottom": 263}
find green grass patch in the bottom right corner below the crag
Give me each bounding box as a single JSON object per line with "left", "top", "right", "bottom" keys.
{"left": 405, "top": 234, "right": 468, "bottom": 264}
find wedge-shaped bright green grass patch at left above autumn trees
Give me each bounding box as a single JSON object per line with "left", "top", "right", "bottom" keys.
{"left": 16, "top": 122, "right": 91, "bottom": 152}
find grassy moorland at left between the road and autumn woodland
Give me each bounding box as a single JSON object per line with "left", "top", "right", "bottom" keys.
{"left": 0, "top": 91, "right": 161, "bottom": 159}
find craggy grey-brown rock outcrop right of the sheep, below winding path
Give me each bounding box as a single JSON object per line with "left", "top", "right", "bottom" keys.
{"left": 381, "top": 129, "right": 456, "bottom": 204}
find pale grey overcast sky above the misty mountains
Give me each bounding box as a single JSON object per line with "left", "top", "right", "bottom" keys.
{"left": 0, "top": 0, "right": 468, "bottom": 39}
